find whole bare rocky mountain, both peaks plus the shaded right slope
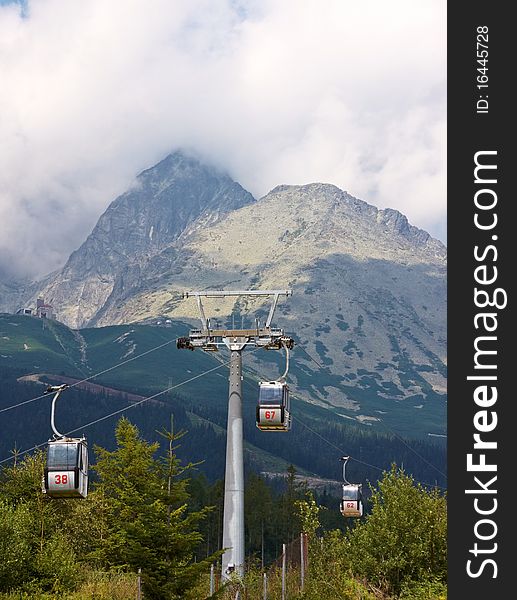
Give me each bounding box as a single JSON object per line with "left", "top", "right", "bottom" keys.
{"left": 24, "top": 153, "right": 447, "bottom": 431}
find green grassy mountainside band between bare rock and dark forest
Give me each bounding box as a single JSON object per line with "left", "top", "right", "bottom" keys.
{"left": 0, "top": 314, "right": 446, "bottom": 437}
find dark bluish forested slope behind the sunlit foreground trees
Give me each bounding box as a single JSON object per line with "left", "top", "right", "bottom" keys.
{"left": 0, "top": 369, "right": 447, "bottom": 493}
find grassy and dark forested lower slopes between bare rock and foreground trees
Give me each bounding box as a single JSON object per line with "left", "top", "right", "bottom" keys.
{"left": 0, "top": 314, "right": 447, "bottom": 482}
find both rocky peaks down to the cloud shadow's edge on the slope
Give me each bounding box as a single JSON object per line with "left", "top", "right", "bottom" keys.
{"left": 24, "top": 150, "right": 446, "bottom": 336}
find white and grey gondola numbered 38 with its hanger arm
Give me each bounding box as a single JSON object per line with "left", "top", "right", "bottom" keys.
{"left": 42, "top": 384, "right": 88, "bottom": 498}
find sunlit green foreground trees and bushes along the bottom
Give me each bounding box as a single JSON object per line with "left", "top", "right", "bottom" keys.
{"left": 0, "top": 417, "right": 447, "bottom": 600}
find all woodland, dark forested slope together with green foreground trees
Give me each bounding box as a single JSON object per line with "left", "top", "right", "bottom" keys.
{"left": 0, "top": 328, "right": 447, "bottom": 600}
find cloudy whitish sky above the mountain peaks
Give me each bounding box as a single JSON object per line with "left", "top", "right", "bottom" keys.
{"left": 0, "top": 0, "right": 446, "bottom": 277}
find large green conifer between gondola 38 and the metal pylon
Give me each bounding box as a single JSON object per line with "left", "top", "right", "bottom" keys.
{"left": 94, "top": 418, "right": 220, "bottom": 600}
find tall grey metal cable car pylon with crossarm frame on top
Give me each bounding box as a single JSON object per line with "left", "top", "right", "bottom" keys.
{"left": 176, "top": 290, "right": 294, "bottom": 580}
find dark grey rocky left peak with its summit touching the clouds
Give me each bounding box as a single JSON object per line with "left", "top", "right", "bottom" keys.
{"left": 28, "top": 152, "right": 254, "bottom": 328}
